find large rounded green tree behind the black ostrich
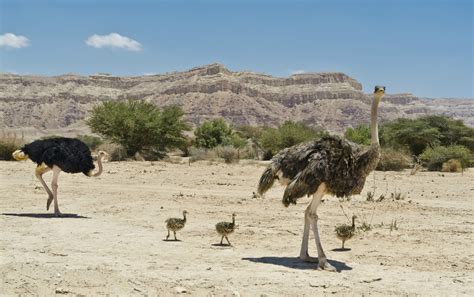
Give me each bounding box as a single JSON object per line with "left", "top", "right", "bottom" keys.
{"left": 87, "top": 100, "right": 190, "bottom": 156}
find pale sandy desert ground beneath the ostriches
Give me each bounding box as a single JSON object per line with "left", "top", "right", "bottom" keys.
{"left": 0, "top": 161, "right": 474, "bottom": 296}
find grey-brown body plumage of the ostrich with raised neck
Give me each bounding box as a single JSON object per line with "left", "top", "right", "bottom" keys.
{"left": 258, "top": 136, "right": 380, "bottom": 206}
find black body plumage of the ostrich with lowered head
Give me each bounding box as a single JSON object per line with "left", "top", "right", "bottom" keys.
{"left": 20, "top": 137, "right": 95, "bottom": 175}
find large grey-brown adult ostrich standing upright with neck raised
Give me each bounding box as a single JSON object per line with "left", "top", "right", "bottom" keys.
{"left": 258, "top": 86, "right": 385, "bottom": 271}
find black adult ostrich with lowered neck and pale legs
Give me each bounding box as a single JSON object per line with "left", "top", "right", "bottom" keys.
{"left": 12, "top": 137, "right": 107, "bottom": 217}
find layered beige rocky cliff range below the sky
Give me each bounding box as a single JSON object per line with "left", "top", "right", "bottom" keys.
{"left": 0, "top": 64, "right": 474, "bottom": 138}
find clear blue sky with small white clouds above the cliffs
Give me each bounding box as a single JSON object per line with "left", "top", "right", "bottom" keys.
{"left": 0, "top": 0, "right": 474, "bottom": 97}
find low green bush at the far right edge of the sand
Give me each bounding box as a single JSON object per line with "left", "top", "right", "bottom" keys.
{"left": 420, "top": 145, "right": 471, "bottom": 171}
